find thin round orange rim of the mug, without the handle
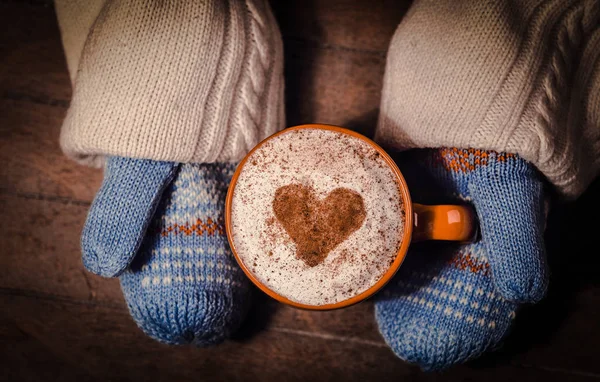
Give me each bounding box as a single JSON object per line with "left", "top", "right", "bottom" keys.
{"left": 225, "top": 123, "right": 414, "bottom": 310}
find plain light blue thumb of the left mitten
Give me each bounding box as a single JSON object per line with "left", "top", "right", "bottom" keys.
{"left": 81, "top": 157, "right": 179, "bottom": 277}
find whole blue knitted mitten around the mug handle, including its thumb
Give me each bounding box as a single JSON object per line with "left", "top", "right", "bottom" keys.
{"left": 375, "top": 149, "right": 548, "bottom": 370}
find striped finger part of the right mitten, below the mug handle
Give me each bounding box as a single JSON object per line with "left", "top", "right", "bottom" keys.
{"left": 375, "top": 244, "right": 517, "bottom": 370}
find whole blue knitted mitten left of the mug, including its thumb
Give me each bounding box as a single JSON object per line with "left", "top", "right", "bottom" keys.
{"left": 82, "top": 157, "right": 250, "bottom": 346}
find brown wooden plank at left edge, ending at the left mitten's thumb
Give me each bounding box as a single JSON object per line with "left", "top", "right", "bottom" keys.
{"left": 0, "top": 99, "right": 102, "bottom": 205}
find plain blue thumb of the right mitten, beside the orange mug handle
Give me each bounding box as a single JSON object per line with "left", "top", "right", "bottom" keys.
{"left": 469, "top": 154, "right": 549, "bottom": 302}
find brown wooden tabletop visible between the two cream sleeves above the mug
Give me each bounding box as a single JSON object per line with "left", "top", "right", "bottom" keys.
{"left": 271, "top": 0, "right": 411, "bottom": 136}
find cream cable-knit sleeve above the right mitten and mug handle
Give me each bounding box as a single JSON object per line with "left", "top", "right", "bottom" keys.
{"left": 376, "top": 0, "right": 600, "bottom": 197}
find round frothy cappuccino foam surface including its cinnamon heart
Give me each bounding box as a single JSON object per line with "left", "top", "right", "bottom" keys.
{"left": 231, "top": 129, "right": 405, "bottom": 305}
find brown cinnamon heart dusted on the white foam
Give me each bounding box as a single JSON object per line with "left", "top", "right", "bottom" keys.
{"left": 273, "top": 184, "right": 367, "bottom": 267}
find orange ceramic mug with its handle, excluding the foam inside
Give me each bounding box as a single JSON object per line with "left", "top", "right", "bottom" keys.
{"left": 225, "top": 124, "right": 478, "bottom": 310}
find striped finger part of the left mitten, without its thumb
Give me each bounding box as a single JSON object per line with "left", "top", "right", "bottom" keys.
{"left": 120, "top": 164, "right": 251, "bottom": 346}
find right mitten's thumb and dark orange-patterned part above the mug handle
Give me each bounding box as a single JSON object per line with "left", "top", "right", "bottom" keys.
{"left": 402, "top": 149, "right": 548, "bottom": 302}
